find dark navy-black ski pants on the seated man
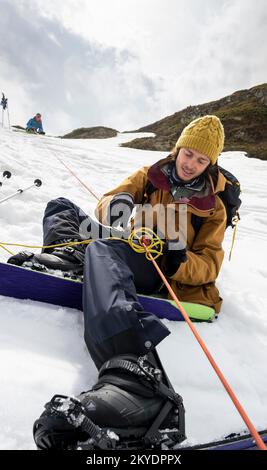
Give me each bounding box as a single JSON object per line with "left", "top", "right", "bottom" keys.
{"left": 43, "top": 198, "right": 170, "bottom": 369}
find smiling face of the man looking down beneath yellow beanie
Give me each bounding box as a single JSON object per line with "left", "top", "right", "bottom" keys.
{"left": 176, "top": 147, "right": 210, "bottom": 181}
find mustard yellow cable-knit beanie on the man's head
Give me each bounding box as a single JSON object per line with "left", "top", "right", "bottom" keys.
{"left": 175, "top": 115, "right": 224, "bottom": 165}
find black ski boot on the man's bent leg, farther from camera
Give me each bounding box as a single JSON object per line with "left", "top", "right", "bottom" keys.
{"left": 7, "top": 239, "right": 86, "bottom": 274}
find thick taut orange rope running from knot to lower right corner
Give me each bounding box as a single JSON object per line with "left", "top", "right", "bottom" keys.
{"left": 142, "top": 243, "right": 267, "bottom": 450}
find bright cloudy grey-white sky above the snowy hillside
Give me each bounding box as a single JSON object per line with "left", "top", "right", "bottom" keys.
{"left": 0, "top": 0, "right": 267, "bottom": 133}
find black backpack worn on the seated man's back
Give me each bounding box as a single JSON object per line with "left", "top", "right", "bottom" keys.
{"left": 145, "top": 166, "right": 242, "bottom": 234}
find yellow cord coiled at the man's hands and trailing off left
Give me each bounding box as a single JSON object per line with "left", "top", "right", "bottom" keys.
{"left": 0, "top": 227, "right": 164, "bottom": 259}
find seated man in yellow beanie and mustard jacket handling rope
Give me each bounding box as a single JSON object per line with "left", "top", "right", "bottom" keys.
{"left": 9, "top": 115, "right": 226, "bottom": 448}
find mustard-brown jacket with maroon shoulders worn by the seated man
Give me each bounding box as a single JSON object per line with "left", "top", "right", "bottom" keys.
{"left": 96, "top": 155, "right": 226, "bottom": 313}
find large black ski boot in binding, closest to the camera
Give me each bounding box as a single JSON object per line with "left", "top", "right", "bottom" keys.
{"left": 33, "top": 353, "right": 185, "bottom": 450}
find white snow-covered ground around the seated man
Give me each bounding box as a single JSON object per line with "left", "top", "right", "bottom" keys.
{"left": 0, "top": 130, "right": 267, "bottom": 449}
